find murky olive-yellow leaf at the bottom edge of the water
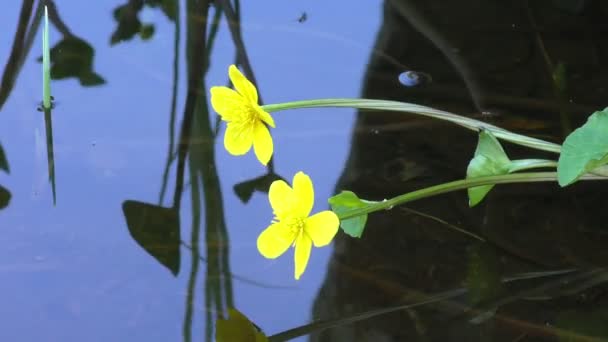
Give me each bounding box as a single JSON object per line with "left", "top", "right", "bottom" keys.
{"left": 215, "top": 308, "right": 268, "bottom": 342}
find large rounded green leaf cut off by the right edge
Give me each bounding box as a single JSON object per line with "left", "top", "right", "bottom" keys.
{"left": 557, "top": 108, "right": 608, "bottom": 187}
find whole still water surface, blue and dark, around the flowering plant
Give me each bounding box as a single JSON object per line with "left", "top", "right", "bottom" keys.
{"left": 0, "top": 0, "right": 608, "bottom": 341}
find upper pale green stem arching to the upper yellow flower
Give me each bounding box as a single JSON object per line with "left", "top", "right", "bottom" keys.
{"left": 262, "top": 99, "right": 561, "bottom": 153}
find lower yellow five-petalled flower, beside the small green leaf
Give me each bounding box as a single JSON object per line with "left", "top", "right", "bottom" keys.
{"left": 258, "top": 172, "right": 340, "bottom": 279}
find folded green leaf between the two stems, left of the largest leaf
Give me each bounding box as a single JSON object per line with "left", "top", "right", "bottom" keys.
{"left": 467, "top": 130, "right": 511, "bottom": 207}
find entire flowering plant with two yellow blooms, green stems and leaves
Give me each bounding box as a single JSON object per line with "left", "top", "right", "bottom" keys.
{"left": 211, "top": 65, "right": 608, "bottom": 264}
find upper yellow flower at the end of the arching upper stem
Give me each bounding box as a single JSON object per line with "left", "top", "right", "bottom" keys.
{"left": 210, "top": 65, "right": 274, "bottom": 165}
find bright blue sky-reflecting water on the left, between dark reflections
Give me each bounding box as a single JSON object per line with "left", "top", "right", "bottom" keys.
{"left": 0, "top": 0, "right": 381, "bottom": 341}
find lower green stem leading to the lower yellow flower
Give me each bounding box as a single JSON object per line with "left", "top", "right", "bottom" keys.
{"left": 338, "top": 172, "right": 606, "bottom": 220}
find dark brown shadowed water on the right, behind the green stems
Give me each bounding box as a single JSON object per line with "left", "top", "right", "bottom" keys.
{"left": 311, "top": 0, "right": 608, "bottom": 341}
